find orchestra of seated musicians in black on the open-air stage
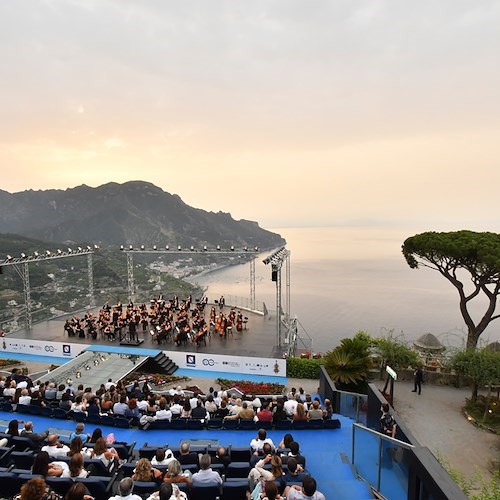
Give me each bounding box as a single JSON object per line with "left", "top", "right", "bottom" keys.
{"left": 64, "top": 294, "right": 248, "bottom": 348}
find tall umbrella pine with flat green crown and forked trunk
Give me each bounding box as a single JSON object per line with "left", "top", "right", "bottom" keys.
{"left": 402, "top": 231, "right": 500, "bottom": 348}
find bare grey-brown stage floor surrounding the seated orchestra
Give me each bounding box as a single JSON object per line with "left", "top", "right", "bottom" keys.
{"left": 7, "top": 305, "right": 284, "bottom": 359}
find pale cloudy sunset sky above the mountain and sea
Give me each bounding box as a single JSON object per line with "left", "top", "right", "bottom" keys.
{"left": 0, "top": 0, "right": 500, "bottom": 232}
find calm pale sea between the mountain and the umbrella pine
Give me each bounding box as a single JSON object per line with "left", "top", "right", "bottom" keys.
{"left": 188, "top": 226, "right": 500, "bottom": 353}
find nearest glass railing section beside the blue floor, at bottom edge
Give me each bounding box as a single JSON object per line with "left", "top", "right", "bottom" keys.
{"left": 352, "top": 424, "right": 413, "bottom": 500}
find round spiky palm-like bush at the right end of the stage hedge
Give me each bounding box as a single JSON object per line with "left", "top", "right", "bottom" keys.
{"left": 324, "top": 332, "right": 371, "bottom": 391}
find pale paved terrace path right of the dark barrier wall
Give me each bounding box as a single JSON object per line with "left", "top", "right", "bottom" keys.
{"left": 381, "top": 382, "right": 500, "bottom": 478}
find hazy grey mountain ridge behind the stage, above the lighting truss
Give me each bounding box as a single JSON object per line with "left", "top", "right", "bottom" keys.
{"left": 0, "top": 181, "right": 285, "bottom": 250}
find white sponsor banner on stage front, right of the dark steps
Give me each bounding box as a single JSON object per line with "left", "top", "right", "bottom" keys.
{"left": 165, "top": 351, "right": 286, "bottom": 377}
